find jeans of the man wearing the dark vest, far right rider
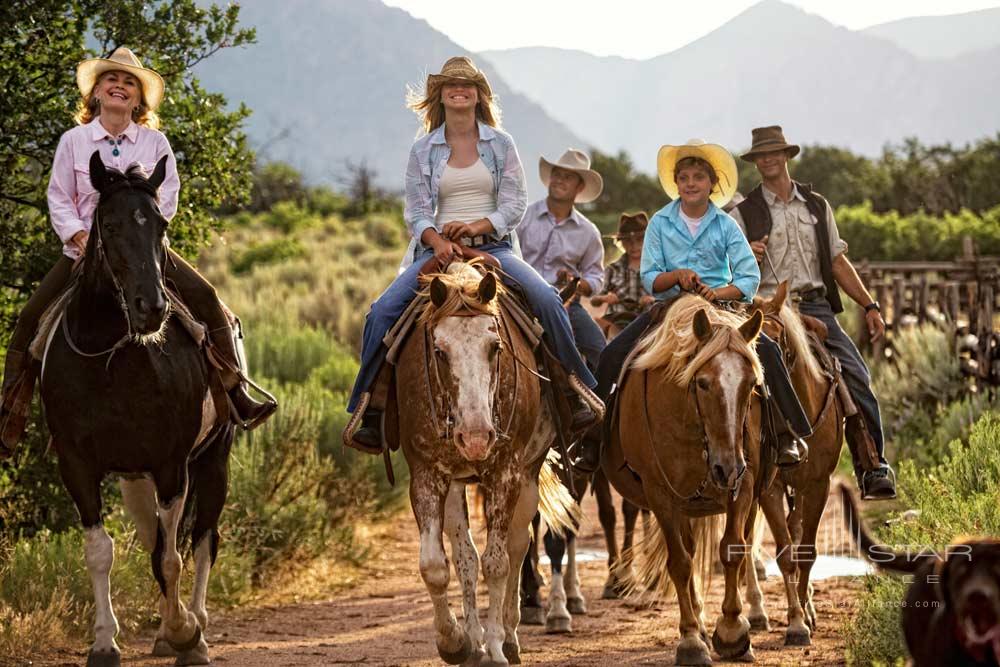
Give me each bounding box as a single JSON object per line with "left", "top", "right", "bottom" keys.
{"left": 799, "top": 299, "right": 887, "bottom": 464}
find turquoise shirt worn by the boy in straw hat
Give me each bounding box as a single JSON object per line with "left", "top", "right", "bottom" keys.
{"left": 639, "top": 199, "right": 760, "bottom": 302}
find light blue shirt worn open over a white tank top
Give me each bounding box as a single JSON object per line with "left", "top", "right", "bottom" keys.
{"left": 400, "top": 122, "right": 528, "bottom": 269}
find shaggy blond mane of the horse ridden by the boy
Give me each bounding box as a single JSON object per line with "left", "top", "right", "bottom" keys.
{"left": 632, "top": 294, "right": 764, "bottom": 387}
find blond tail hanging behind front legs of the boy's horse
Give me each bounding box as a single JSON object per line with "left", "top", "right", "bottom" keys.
{"left": 621, "top": 514, "right": 726, "bottom": 598}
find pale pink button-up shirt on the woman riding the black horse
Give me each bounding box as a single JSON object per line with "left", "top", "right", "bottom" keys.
{"left": 48, "top": 118, "right": 181, "bottom": 259}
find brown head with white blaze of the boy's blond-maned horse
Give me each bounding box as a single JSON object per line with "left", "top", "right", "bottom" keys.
{"left": 689, "top": 309, "right": 764, "bottom": 490}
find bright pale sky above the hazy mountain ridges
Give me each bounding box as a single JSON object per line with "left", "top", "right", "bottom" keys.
{"left": 383, "top": 0, "right": 1000, "bottom": 58}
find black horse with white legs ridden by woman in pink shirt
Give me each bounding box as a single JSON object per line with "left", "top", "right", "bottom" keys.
{"left": 41, "top": 152, "right": 233, "bottom": 667}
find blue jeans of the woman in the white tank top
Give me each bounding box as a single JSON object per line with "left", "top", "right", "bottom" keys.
{"left": 347, "top": 241, "right": 597, "bottom": 412}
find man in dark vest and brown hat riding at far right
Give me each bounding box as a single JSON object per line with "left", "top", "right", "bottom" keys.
{"left": 730, "top": 125, "right": 896, "bottom": 499}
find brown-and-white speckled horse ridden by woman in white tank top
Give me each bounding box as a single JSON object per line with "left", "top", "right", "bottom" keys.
{"left": 387, "top": 263, "right": 572, "bottom": 666}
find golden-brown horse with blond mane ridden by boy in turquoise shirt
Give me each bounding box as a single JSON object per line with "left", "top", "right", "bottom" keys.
{"left": 602, "top": 295, "right": 763, "bottom": 665}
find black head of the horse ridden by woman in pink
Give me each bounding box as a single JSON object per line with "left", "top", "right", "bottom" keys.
{"left": 87, "top": 151, "right": 167, "bottom": 336}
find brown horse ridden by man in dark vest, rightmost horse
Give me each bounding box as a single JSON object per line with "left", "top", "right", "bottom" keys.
{"left": 747, "top": 283, "right": 844, "bottom": 646}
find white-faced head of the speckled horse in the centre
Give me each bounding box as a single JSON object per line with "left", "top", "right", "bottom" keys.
{"left": 427, "top": 265, "right": 501, "bottom": 461}
